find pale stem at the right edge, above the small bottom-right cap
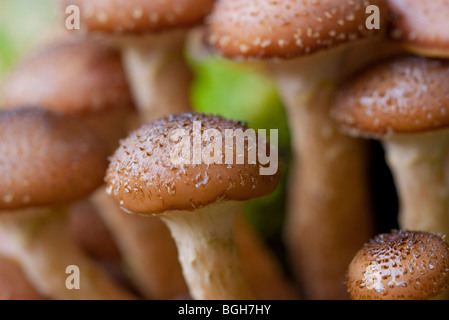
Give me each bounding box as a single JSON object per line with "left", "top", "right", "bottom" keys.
{"left": 383, "top": 130, "right": 449, "bottom": 240}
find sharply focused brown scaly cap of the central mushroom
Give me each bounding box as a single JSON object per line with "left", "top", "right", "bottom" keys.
{"left": 106, "top": 113, "right": 280, "bottom": 214}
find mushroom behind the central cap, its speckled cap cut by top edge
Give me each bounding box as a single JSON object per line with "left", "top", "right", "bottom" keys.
{"left": 62, "top": 0, "right": 213, "bottom": 122}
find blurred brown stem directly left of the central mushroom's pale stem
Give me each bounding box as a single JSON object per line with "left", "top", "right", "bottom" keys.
{"left": 91, "top": 188, "right": 188, "bottom": 300}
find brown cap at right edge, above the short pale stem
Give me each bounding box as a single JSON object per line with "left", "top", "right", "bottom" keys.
{"left": 333, "top": 56, "right": 449, "bottom": 136}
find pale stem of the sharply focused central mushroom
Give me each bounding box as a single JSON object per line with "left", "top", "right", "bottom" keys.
{"left": 162, "top": 201, "right": 254, "bottom": 300}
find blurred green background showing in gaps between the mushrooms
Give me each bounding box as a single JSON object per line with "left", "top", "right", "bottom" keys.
{"left": 0, "top": 0, "right": 290, "bottom": 243}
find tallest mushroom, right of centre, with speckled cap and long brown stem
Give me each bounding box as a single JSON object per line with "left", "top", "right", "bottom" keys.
{"left": 208, "top": 0, "right": 388, "bottom": 299}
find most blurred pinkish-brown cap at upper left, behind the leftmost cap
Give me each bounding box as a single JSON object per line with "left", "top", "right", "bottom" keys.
{"left": 3, "top": 38, "right": 134, "bottom": 116}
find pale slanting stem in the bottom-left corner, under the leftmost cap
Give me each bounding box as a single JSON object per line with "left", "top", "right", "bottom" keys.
{"left": 0, "top": 208, "right": 134, "bottom": 300}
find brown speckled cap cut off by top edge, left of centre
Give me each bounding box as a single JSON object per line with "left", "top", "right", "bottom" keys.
{"left": 62, "top": 0, "right": 214, "bottom": 34}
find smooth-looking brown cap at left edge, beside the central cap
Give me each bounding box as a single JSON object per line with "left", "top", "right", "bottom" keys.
{"left": 0, "top": 108, "right": 108, "bottom": 210}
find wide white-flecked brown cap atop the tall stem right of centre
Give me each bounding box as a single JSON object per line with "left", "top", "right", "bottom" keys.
{"left": 208, "top": 0, "right": 388, "bottom": 58}
